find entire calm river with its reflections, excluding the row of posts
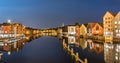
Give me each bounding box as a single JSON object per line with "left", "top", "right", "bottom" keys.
{"left": 0, "top": 36, "right": 120, "bottom": 63}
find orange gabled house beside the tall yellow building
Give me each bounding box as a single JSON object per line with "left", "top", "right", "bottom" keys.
{"left": 93, "top": 23, "right": 104, "bottom": 35}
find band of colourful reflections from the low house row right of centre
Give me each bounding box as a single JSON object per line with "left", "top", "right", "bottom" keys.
{"left": 63, "top": 36, "right": 104, "bottom": 54}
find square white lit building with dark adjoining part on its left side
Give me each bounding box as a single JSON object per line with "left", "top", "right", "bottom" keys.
{"left": 63, "top": 25, "right": 76, "bottom": 35}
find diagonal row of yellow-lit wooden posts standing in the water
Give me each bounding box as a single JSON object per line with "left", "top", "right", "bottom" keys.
{"left": 63, "top": 39, "right": 88, "bottom": 63}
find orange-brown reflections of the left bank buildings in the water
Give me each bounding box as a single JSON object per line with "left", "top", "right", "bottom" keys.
{"left": 0, "top": 34, "right": 41, "bottom": 62}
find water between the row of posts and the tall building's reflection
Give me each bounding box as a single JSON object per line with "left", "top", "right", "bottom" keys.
{"left": 63, "top": 36, "right": 105, "bottom": 63}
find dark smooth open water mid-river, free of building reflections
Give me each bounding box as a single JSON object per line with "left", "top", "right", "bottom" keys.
{"left": 2, "top": 37, "right": 72, "bottom": 63}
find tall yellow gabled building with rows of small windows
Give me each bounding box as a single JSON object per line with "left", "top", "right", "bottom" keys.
{"left": 103, "top": 11, "right": 115, "bottom": 42}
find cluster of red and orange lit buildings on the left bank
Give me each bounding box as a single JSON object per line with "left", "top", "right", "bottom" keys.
{"left": 0, "top": 21, "right": 25, "bottom": 34}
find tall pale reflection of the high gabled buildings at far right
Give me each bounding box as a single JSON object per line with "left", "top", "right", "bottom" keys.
{"left": 104, "top": 43, "right": 120, "bottom": 63}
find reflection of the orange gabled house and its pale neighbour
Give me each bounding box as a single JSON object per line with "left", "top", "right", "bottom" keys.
{"left": 88, "top": 40, "right": 104, "bottom": 54}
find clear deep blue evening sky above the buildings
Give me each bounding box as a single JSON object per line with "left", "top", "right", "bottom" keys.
{"left": 0, "top": 0, "right": 120, "bottom": 28}
